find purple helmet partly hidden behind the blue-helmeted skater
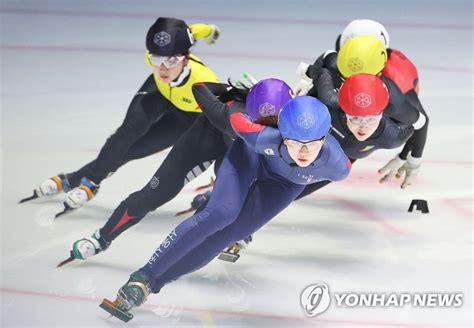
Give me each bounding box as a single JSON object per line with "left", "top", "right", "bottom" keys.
{"left": 246, "top": 79, "right": 293, "bottom": 121}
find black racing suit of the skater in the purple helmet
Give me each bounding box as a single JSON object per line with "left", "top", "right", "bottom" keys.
{"left": 94, "top": 83, "right": 245, "bottom": 248}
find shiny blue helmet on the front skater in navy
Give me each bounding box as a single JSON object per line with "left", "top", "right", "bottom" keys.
{"left": 278, "top": 96, "right": 331, "bottom": 140}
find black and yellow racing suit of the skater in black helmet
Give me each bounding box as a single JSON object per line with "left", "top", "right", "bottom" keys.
{"left": 67, "top": 24, "right": 218, "bottom": 188}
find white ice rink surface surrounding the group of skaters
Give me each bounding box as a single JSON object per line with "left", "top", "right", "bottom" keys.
{"left": 0, "top": 0, "right": 473, "bottom": 327}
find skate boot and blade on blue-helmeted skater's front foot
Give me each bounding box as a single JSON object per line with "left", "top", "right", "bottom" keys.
{"left": 100, "top": 271, "right": 151, "bottom": 322}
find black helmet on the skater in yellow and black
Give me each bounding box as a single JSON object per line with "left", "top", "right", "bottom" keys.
{"left": 146, "top": 17, "right": 194, "bottom": 56}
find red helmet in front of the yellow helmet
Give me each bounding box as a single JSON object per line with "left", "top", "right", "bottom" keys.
{"left": 339, "top": 73, "right": 389, "bottom": 116}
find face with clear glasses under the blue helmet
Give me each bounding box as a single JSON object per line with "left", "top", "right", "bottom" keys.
{"left": 283, "top": 137, "right": 326, "bottom": 167}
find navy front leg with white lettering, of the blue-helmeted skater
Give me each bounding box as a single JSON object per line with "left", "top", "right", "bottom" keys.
{"left": 140, "top": 140, "right": 260, "bottom": 281}
